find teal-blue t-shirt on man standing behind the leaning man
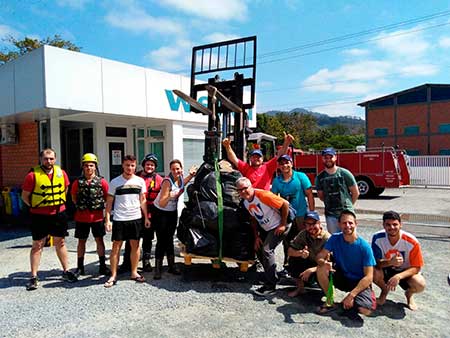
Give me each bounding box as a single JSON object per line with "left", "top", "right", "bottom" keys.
{"left": 272, "top": 171, "right": 311, "bottom": 217}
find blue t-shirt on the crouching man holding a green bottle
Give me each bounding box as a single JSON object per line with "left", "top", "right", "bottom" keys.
{"left": 324, "top": 232, "right": 376, "bottom": 281}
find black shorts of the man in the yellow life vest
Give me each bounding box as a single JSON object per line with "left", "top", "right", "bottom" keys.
{"left": 31, "top": 211, "right": 68, "bottom": 241}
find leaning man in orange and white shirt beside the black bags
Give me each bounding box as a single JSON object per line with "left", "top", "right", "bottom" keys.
{"left": 236, "top": 177, "right": 290, "bottom": 296}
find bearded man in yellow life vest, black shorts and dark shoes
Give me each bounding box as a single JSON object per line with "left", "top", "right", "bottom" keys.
{"left": 22, "top": 148, "right": 77, "bottom": 291}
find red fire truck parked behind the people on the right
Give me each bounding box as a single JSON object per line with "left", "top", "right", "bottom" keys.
{"left": 249, "top": 133, "right": 410, "bottom": 197}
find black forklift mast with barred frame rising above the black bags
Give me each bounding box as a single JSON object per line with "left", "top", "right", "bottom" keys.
{"left": 190, "top": 36, "right": 256, "bottom": 164}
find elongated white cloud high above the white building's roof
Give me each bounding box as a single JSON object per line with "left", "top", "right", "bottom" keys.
{"left": 106, "top": 6, "right": 184, "bottom": 35}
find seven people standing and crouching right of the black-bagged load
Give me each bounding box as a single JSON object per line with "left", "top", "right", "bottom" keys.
{"left": 229, "top": 135, "right": 425, "bottom": 315}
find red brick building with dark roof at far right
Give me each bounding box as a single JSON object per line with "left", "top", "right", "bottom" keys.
{"left": 359, "top": 84, "right": 450, "bottom": 155}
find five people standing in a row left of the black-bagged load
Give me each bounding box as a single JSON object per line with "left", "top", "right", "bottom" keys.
{"left": 22, "top": 148, "right": 196, "bottom": 290}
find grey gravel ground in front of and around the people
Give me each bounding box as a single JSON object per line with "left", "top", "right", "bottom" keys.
{"left": 0, "top": 190, "right": 450, "bottom": 338}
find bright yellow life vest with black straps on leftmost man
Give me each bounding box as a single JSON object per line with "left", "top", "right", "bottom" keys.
{"left": 31, "top": 165, "right": 66, "bottom": 208}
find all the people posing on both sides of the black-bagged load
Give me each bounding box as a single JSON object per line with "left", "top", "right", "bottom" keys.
{"left": 22, "top": 140, "right": 425, "bottom": 315}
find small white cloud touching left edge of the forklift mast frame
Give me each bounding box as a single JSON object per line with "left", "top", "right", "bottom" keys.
{"left": 146, "top": 40, "right": 192, "bottom": 72}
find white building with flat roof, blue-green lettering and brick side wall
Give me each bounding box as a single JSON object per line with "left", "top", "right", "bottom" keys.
{"left": 0, "top": 46, "right": 256, "bottom": 186}
